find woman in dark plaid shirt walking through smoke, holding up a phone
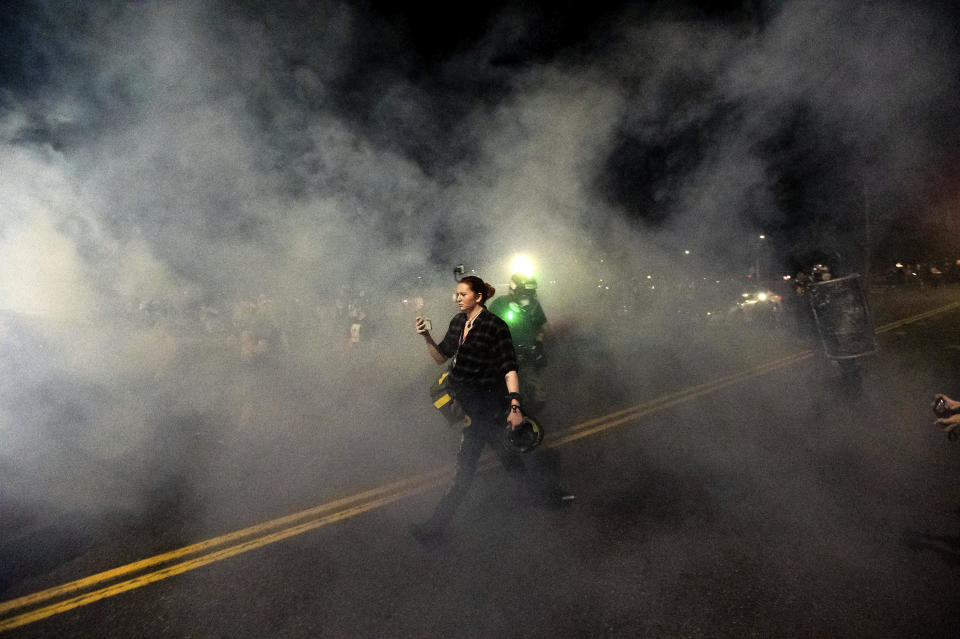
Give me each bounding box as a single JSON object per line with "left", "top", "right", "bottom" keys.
{"left": 411, "top": 275, "right": 528, "bottom": 544}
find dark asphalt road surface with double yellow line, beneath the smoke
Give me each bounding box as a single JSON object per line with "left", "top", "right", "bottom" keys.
{"left": 0, "top": 289, "right": 960, "bottom": 637}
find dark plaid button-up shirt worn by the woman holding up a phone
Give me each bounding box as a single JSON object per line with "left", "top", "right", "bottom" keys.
{"left": 437, "top": 309, "right": 517, "bottom": 388}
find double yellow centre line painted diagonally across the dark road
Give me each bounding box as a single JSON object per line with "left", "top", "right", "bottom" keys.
{"left": 0, "top": 302, "right": 960, "bottom": 632}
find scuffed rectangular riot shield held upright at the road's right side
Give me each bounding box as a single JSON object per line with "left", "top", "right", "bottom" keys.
{"left": 807, "top": 274, "right": 877, "bottom": 360}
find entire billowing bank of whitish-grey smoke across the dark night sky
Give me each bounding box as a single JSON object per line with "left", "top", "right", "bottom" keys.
{"left": 0, "top": 2, "right": 956, "bottom": 540}
